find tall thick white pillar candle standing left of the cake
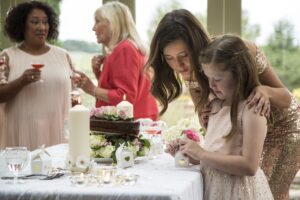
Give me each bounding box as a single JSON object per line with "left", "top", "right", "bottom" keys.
{"left": 69, "top": 105, "right": 90, "bottom": 171}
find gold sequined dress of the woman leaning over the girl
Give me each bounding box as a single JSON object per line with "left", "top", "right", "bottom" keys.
{"left": 190, "top": 46, "right": 300, "bottom": 200}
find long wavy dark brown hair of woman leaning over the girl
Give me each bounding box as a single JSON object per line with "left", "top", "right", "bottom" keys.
{"left": 146, "top": 9, "right": 209, "bottom": 115}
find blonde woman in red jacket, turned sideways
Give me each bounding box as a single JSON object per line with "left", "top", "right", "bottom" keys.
{"left": 73, "top": 2, "right": 158, "bottom": 120}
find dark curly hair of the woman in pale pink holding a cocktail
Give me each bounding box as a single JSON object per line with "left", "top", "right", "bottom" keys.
{"left": 4, "top": 1, "right": 59, "bottom": 42}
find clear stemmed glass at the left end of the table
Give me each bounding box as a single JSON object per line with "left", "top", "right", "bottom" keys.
{"left": 4, "top": 147, "right": 29, "bottom": 184}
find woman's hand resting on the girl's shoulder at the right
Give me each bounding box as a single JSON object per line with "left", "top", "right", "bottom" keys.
{"left": 247, "top": 85, "right": 271, "bottom": 117}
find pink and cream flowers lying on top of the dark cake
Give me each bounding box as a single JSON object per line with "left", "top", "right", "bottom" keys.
{"left": 90, "top": 106, "right": 133, "bottom": 121}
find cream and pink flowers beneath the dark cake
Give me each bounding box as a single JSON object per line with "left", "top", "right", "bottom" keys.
{"left": 90, "top": 134, "right": 150, "bottom": 162}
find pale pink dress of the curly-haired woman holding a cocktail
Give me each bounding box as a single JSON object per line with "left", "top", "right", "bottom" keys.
{"left": 0, "top": 45, "right": 71, "bottom": 150}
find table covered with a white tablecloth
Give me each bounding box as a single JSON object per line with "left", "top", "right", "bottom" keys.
{"left": 0, "top": 144, "right": 203, "bottom": 200}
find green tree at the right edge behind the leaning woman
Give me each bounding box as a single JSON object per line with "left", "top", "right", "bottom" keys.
{"left": 264, "top": 20, "right": 300, "bottom": 89}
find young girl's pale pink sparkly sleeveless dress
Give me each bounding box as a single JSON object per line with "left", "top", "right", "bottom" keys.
{"left": 201, "top": 101, "right": 273, "bottom": 200}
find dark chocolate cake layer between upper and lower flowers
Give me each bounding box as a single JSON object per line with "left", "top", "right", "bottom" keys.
{"left": 90, "top": 116, "right": 140, "bottom": 136}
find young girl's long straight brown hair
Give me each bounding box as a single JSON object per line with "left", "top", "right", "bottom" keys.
{"left": 199, "top": 35, "right": 260, "bottom": 138}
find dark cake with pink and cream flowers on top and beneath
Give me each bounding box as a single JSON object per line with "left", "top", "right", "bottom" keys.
{"left": 90, "top": 105, "right": 151, "bottom": 163}
